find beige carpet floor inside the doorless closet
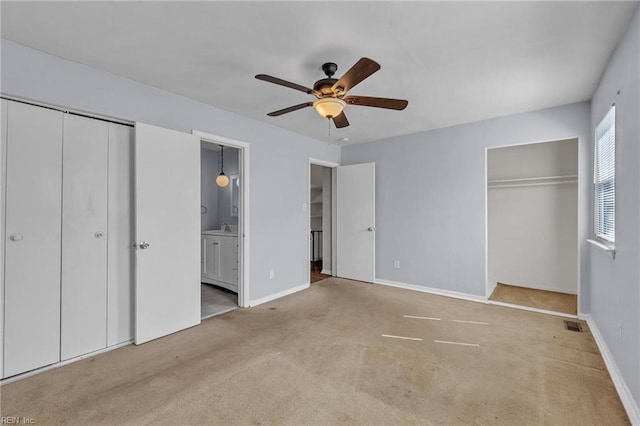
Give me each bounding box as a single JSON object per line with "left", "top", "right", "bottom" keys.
{"left": 489, "top": 283, "right": 578, "bottom": 315}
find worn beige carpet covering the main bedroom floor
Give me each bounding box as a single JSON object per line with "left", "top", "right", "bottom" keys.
{"left": 1, "top": 278, "right": 629, "bottom": 425}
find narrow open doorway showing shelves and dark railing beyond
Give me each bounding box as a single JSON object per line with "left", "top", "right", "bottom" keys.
{"left": 308, "top": 160, "right": 337, "bottom": 283}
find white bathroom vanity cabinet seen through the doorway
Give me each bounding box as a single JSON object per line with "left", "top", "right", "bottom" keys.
{"left": 201, "top": 231, "right": 238, "bottom": 293}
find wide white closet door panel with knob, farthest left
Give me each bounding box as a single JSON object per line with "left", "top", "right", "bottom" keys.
{"left": 3, "top": 102, "right": 62, "bottom": 377}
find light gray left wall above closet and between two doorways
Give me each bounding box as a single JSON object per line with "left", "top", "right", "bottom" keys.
{"left": 0, "top": 40, "right": 340, "bottom": 300}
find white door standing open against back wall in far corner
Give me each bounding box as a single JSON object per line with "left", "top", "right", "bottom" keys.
{"left": 336, "top": 163, "right": 376, "bottom": 282}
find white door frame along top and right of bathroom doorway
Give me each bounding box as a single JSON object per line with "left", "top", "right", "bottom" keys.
{"left": 191, "top": 129, "right": 251, "bottom": 308}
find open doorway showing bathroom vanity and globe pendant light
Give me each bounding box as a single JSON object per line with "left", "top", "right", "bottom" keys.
{"left": 200, "top": 140, "right": 244, "bottom": 319}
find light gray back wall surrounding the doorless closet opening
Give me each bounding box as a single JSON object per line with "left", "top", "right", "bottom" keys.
{"left": 342, "top": 102, "right": 590, "bottom": 302}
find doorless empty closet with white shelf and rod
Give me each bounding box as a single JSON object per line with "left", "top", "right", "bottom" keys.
{"left": 487, "top": 139, "right": 579, "bottom": 315}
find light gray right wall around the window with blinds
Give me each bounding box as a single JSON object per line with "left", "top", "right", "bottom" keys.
{"left": 589, "top": 4, "right": 640, "bottom": 406}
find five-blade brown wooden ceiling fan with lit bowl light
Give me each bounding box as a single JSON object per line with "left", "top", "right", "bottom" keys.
{"left": 256, "top": 58, "right": 409, "bottom": 128}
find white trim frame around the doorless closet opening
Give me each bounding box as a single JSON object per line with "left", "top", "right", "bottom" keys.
{"left": 484, "top": 136, "right": 588, "bottom": 317}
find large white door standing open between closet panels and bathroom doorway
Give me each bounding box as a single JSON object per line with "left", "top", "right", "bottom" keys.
{"left": 135, "top": 123, "right": 200, "bottom": 344}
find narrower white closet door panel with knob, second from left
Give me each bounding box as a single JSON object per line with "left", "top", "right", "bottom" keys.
{"left": 60, "top": 114, "right": 109, "bottom": 360}
